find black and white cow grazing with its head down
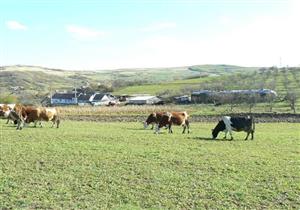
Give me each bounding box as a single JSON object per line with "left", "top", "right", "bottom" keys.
{"left": 212, "top": 116, "right": 255, "bottom": 140}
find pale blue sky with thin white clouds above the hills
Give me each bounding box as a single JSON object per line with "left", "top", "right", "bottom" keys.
{"left": 0, "top": 0, "right": 300, "bottom": 70}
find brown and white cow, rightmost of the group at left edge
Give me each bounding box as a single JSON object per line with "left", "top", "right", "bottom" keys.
{"left": 25, "top": 107, "right": 60, "bottom": 128}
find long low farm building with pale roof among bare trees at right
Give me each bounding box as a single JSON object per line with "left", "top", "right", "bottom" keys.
{"left": 191, "top": 89, "right": 277, "bottom": 104}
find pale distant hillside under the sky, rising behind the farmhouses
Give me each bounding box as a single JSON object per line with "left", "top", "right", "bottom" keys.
{"left": 0, "top": 65, "right": 257, "bottom": 103}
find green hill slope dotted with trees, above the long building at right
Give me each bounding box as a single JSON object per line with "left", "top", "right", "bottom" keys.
{"left": 114, "top": 68, "right": 300, "bottom": 95}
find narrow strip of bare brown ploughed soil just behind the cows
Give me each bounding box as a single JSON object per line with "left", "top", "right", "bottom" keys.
{"left": 62, "top": 113, "right": 300, "bottom": 123}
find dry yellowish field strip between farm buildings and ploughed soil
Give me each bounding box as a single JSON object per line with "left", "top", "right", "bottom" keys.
{"left": 57, "top": 103, "right": 300, "bottom": 119}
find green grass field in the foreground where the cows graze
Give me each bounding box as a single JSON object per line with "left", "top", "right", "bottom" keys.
{"left": 0, "top": 120, "right": 300, "bottom": 209}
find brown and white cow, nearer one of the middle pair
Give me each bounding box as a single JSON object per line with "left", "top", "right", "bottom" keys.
{"left": 156, "top": 112, "right": 190, "bottom": 133}
